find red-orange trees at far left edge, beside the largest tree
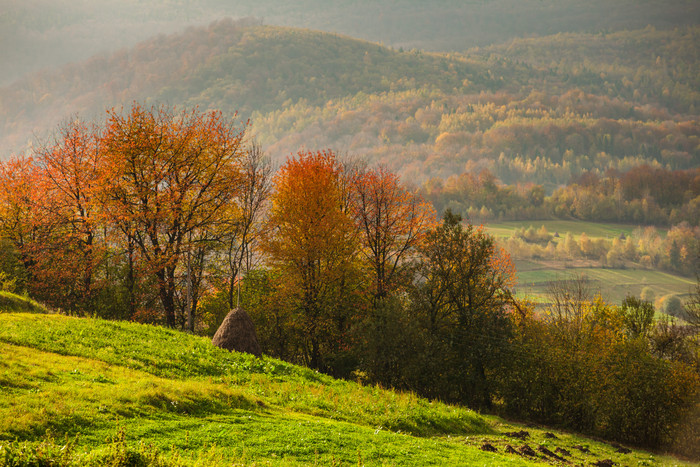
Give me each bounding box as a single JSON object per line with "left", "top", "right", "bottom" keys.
{"left": 0, "top": 119, "right": 102, "bottom": 311}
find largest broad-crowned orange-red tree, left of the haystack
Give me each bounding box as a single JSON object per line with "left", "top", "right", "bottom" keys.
{"left": 101, "top": 105, "right": 246, "bottom": 327}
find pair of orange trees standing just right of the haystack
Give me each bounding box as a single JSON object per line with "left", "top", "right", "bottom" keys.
{"left": 243, "top": 152, "right": 434, "bottom": 376}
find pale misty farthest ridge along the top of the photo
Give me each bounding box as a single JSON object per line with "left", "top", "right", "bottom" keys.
{"left": 0, "top": 0, "right": 700, "bottom": 85}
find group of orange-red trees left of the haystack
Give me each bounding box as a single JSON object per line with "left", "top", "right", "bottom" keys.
{"left": 0, "top": 105, "right": 270, "bottom": 330}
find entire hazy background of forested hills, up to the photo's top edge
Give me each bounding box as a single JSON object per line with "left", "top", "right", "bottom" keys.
{"left": 0, "top": 0, "right": 700, "bottom": 186}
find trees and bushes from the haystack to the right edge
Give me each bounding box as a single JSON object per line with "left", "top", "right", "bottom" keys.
{"left": 230, "top": 148, "right": 700, "bottom": 455}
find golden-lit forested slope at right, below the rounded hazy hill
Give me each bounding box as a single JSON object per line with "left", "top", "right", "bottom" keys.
{"left": 254, "top": 29, "right": 700, "bottom": 187}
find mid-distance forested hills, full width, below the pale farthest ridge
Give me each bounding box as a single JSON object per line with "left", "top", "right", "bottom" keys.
{"left": 0, "top": 21, "right": 700, "bottom": 192}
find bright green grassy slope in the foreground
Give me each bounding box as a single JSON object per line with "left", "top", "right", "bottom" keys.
{"left": 0, "top": 298, "right": 683, "bottom": 466}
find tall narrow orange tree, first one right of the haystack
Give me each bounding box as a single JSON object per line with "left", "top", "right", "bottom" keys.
{"left": 263, "top": 152, "right": 357, "bottom": 369}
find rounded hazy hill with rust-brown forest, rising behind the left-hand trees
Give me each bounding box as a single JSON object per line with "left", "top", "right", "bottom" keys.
{"left": 0, "top": 20, "right": 489, "bottom": 156}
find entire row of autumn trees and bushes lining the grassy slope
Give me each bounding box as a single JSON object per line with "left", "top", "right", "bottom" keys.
{"left": 0, "top": 105, "right": 700, "bottom": 454}
